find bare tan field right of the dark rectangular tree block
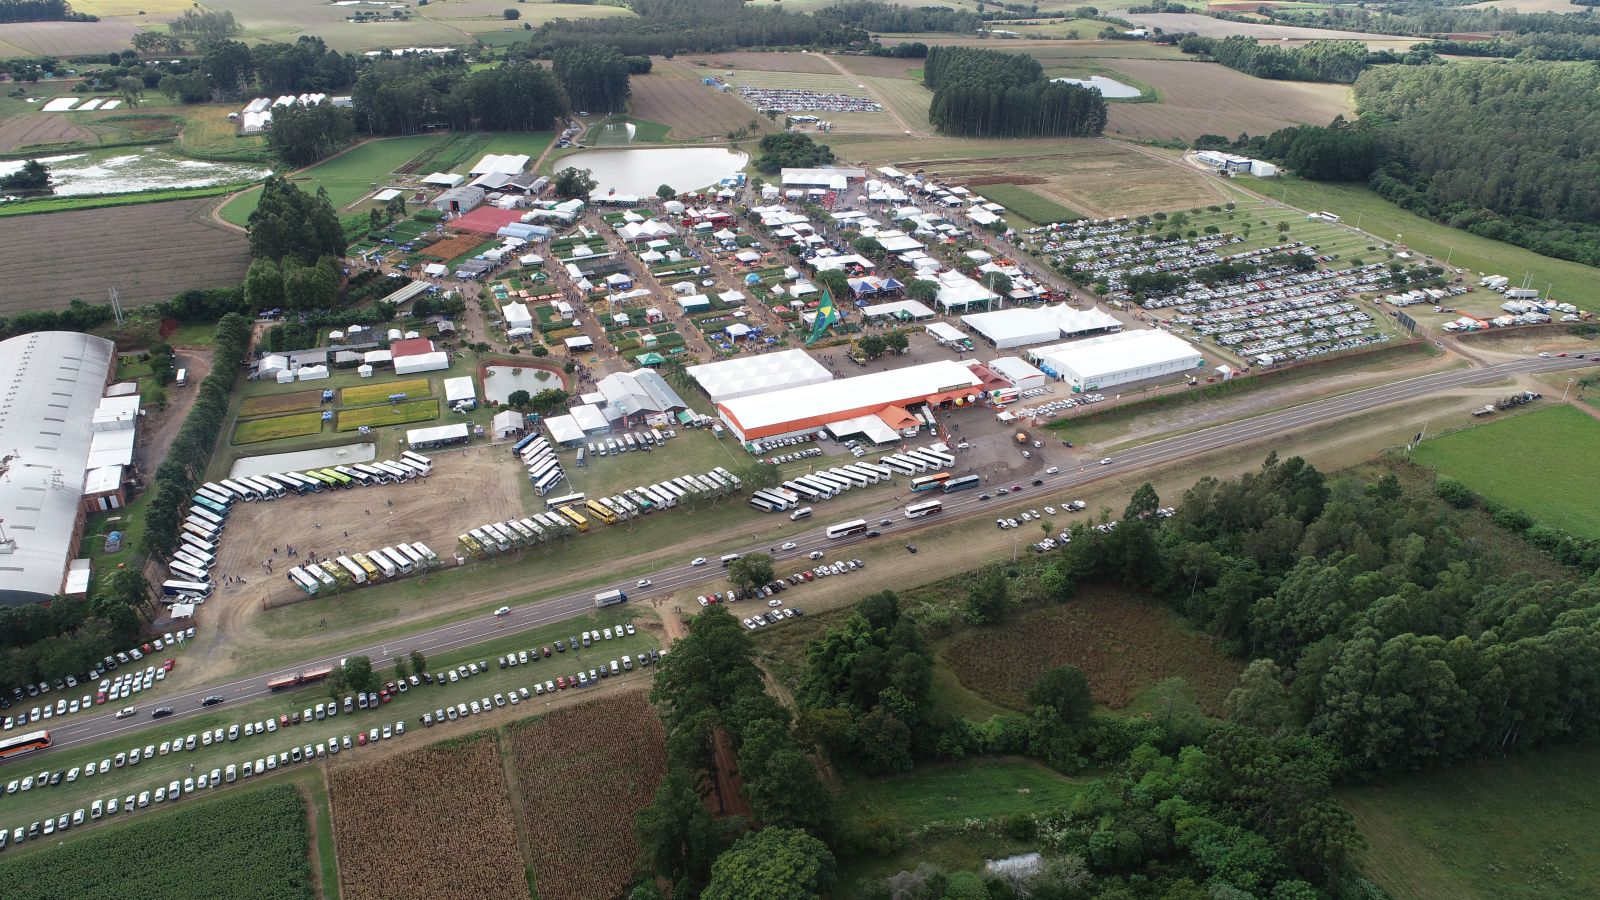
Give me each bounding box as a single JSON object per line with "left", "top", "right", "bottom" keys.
{"left": 1104, "top": 59, "right": 1355, "bottom": 141}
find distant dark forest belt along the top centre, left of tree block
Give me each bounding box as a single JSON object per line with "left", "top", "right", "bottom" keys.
{"left": 528, "top": 0, "right": 869, "bottom": 56}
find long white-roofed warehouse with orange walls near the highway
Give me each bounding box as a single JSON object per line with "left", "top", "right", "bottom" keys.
{"left": 717, "top": 360, "right": 981, "bottom": 440}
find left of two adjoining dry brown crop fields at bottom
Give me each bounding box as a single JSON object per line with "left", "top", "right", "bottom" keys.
{"left": 328, "top": 732, "right": 524, "bottom": 900}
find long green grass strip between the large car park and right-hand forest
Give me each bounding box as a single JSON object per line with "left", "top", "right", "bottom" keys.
{"left": 1238, "top": 176, "right": 1600, "bottom": 306}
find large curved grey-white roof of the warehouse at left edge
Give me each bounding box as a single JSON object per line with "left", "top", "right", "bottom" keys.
{"left": 0, "top": 331, "right": 116, "bottom": 605}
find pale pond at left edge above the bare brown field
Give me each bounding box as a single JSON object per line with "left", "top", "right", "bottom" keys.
{"left": 0, "top": 147, "right": 272, "bottom": 197}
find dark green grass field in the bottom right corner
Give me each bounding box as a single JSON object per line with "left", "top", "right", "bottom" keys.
{"left": 1339, "top": 748, "right": 1600, "bottom": 900}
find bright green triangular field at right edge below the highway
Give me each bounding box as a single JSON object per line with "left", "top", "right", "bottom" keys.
{"left": 1411, "top": 405, "right": 1600, "bottom": 538}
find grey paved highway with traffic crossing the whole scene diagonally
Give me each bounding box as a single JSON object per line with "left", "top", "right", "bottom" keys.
{"left": 31, "top": 357, "right": 1600, "bottom": 753}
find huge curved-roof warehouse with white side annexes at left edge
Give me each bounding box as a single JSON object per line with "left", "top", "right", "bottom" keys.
{"left": 0, "top": 331, "right": 124, "bottom": 605}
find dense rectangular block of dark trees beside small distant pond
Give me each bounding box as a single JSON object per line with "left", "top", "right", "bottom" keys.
{"left": 923, "top": 46, "right": 1106, "bottom": 138}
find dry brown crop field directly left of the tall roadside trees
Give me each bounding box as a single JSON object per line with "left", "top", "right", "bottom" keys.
{"left": 509, "top": 692, "right": 667, "bottom": 900}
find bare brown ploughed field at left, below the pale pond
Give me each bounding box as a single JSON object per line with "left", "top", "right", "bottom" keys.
{"left": 0, "top": 199, "right": 250, "bottom": 314}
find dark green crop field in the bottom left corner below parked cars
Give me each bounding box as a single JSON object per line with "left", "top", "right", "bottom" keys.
{"left": 0, "top": 785, "right": 312, "bottom": 900}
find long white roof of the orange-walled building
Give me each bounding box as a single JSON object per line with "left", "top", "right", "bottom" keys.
{"left": 717, "top": 359, "right": 979, "bottom": 440}
